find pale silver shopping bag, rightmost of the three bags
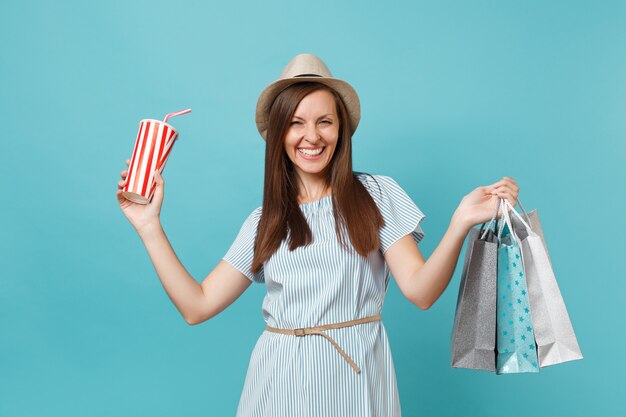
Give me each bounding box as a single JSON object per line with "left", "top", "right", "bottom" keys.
{"left": 504, "top": 200, "right": 583, "bottom": 367}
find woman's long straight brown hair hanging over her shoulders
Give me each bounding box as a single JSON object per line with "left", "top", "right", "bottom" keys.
{"left": 251, "top": 82, "right": 384, "bottom": 273}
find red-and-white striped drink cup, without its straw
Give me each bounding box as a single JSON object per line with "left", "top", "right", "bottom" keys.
{"left": 122, "top": 119, "right": 178, "bottom": 204}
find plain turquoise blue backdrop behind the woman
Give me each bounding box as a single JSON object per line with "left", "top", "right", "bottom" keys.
{"left": 0, "top": 0, "right": 626, "bottom": 417}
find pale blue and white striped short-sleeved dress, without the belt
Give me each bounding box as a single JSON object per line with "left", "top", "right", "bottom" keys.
{"left": 223, "top": 173, "right": 425, "bottom": 417}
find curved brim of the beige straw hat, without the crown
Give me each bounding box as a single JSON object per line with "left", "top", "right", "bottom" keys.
{"left": 256, "top": 76, "right": 361, "bottom": 140}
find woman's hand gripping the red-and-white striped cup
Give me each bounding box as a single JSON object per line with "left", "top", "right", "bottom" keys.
{"left": 116, "top": 159, "right": 164, "bottom": 232}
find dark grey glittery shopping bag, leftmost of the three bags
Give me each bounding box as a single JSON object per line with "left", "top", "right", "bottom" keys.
{"left": 450, "top": 203, "right": 499, "bottom": 372}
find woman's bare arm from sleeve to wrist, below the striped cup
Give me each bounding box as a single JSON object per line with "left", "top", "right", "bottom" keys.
{"left": 138, "top": 223, "right": 252, "bottom": 325}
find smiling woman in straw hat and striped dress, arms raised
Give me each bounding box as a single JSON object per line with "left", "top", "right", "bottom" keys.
{"left": 117, "top": 54, "right": 519, "bottom": 417}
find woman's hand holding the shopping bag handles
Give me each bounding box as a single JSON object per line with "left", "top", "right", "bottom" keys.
{"left": 454, "top": 177, "right": 519, "bottom": 228}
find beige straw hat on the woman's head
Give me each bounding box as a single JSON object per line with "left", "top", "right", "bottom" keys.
{"left": 256, "top": 54, "right": 361, "bottom": 140}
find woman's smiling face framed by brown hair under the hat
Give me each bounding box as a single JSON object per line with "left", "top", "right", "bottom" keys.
{"left": 285, "top": 90, "right": 339, "bottom": 176}
